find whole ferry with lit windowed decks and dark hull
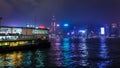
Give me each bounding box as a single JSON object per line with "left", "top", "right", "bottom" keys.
{"left": 0, "top": 26, "right": 50, "bottom": 49}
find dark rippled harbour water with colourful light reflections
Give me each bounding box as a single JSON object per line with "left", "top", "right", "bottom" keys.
{"left": 0, "top": 38, "right": 120, "bottom": 68}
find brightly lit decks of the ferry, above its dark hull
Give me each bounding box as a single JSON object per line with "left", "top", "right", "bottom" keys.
{"left": 0, "top": 26, "right": 49, "bottom": 46}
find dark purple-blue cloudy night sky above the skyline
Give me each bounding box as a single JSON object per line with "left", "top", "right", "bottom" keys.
{"left": 0, "top": 0, "right": 120, "bottom": 26}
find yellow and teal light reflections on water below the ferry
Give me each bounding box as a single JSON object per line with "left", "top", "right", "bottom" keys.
{"left": 0, "top": 50, "right": 45, "bottom": 68}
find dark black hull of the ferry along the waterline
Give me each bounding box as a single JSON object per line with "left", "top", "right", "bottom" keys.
{"left": 0, "top": 39, "right": 50, "bottom": 52}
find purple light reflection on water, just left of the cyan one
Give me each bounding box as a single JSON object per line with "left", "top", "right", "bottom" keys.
{"left": 48, "top": 43, "right": 63, "bottom": 67}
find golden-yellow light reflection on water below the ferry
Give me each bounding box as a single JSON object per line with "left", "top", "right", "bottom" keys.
{"left": 0, "top": 52, "right": 22, "bottom": 68}
